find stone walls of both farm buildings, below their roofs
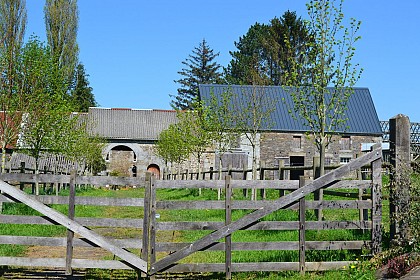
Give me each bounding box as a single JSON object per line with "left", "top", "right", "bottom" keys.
{"left": 106, "top": 132, "right": 382, "bottom": 178}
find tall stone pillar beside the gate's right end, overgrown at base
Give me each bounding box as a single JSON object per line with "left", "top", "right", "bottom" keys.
{"left": 389, "top": 114, "right": 411, "bottom": 242}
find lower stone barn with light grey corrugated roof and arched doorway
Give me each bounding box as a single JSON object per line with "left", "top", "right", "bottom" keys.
{"left": 88, "top": 107, "right": 176, "bottom": 177}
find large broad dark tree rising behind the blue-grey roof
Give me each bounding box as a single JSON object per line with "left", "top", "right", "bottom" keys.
{"left": 225, "top": 11, "right": 311, "bottom": 85}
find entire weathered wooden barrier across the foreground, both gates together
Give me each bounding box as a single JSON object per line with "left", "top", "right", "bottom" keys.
{"left": 0, "top": 144, "right": 381, "bottom": 278}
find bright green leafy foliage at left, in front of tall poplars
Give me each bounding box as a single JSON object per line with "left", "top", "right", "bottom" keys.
{"left": 18, "top": 38, "right": 103, "bottom": 178}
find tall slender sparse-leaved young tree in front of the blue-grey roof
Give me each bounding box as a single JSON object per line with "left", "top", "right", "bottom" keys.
{"left": 285, "top": 0, "right": 362, "bottom": 175}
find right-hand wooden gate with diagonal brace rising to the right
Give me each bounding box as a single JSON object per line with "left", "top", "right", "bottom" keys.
{"left": 143, "top": 145, "right": 382, "bottom": 278}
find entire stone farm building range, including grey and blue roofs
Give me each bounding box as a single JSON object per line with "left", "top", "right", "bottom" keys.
{"left": 88, "top": 85, "right": 382, "bottom": 179}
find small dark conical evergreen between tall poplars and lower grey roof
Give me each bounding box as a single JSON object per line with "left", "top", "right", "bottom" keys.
{"left": 71, "top": 63, "right": 97, "bottom": 112}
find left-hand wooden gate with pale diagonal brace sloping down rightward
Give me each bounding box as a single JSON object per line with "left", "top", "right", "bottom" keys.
{"left": 0, "top": 173, "right": 147, "bottom": 275}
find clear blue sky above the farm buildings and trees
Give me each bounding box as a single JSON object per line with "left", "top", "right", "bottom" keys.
{"left": 26, "top": 0, "right": 420, "bottom": 122}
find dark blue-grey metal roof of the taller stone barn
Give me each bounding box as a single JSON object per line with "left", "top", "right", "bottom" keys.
{"left": 199, "top": 85, "right": 382, "bottom": 136}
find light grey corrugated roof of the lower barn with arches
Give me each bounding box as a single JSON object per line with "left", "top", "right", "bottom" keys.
{"left": 89, "top": 107, "right": 177, "bottom": 140}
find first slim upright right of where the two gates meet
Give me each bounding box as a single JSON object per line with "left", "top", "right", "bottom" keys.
{"left": 225, "top": 175, "right": 232, "bottom": 279}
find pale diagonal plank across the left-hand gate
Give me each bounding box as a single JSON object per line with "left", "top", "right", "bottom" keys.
{"left": 0, "top": 181, "right": 147, "bottom": 271}
